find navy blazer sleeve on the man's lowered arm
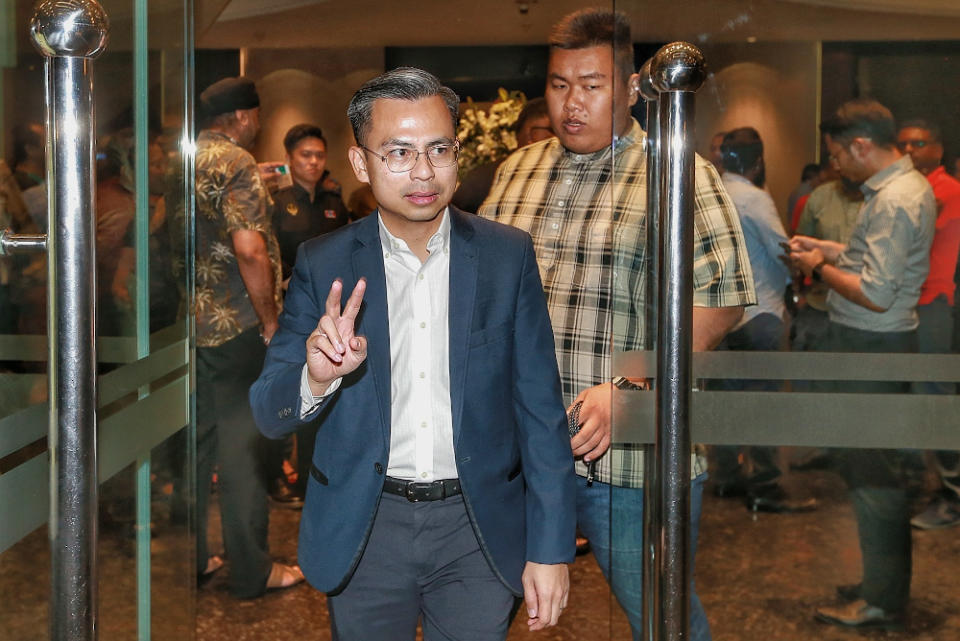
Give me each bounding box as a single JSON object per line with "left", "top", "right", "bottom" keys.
{"left": 513, "top": 235, "right": 576, "bottom": 563}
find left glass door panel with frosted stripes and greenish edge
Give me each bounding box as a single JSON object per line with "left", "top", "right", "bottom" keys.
{"left": 0, "top": 0, "right": 196, "bottom": 639}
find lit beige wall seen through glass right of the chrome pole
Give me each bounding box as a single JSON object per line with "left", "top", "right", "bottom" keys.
{"left": 697, "top": 42, "right": 820, "bottom": 220}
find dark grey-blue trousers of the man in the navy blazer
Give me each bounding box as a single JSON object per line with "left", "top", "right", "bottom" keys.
{"left": 327, "top": 493, "right": 514, "bottom": 641}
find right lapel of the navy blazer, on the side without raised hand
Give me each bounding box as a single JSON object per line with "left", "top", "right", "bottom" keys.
{"left": 449, "top": 206, "right": 477, "bottom": 444}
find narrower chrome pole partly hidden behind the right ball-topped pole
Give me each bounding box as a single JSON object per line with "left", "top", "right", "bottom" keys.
{"left": 640, "top": 59, "right": 661, "bottom": 641}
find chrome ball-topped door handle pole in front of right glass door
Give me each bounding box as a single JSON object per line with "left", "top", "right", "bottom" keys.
{"left": 651, "top": 42, "right": 705, "bottom": 641}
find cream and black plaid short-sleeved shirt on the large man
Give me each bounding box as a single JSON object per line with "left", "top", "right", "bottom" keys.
{"left": 478, "top": 121, "right": 755, "bottom": 487}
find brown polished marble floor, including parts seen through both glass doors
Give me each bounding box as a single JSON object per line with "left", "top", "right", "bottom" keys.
{"left": 0, "top": 452, "right": 960, "bottom": 641}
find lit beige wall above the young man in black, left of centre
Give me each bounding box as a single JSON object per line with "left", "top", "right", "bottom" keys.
{"left": 244, "top": 47, "right": 384, "bottom": 201}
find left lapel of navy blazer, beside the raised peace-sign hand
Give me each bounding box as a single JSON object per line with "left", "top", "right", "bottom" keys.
{"left": 345, "top": 212, "right": 391, "bottom": 449}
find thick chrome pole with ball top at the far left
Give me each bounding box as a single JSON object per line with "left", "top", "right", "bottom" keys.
{"left": 30, "top": 0, "right": 109, "bottom": 641}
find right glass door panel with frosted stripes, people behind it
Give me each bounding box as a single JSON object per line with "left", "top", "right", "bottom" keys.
{"left": 610, "top": 0, "right": 960, "bottom": 640}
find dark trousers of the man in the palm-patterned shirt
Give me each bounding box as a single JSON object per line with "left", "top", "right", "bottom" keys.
{"left": 197, "top": 328, "right": 272, "bottom": 598}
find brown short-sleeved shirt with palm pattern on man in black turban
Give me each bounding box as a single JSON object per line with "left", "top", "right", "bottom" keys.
{"left": 194, "top": 130, "right": 281, "bottom": 347}
